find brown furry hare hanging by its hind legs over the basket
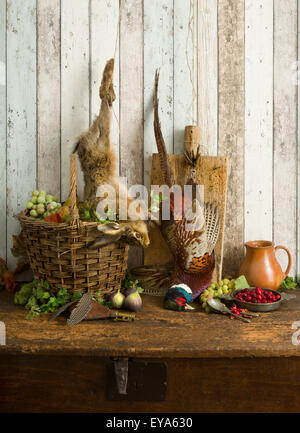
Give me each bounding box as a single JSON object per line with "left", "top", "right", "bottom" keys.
{"left": 74, "top": 59, "right": 149, "bottom": 247}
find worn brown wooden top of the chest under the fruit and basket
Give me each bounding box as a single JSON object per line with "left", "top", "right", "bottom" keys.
{"left": 0, "top": 289, "right": 300, "bottom": 358}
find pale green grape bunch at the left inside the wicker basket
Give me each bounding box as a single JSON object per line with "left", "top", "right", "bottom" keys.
{"left": 26, "top": 190, "right": 61, "bottom": 219}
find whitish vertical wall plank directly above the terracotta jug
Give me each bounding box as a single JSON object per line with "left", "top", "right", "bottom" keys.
{"left": 245, "top": 0, "right": 273, "bottom": 241}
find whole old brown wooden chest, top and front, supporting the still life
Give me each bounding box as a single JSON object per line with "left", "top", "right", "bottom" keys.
{"left": 0, "top": 291, "right": 300, "bottom": 413}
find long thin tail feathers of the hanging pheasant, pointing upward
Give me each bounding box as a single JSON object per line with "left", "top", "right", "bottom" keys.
{"left": 153, "top": 71, "right": 173, "bottom": 187}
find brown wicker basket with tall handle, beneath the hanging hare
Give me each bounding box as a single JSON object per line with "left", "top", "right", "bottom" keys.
{"left": 18, "top": 155, "right": 128, "bottom": 295}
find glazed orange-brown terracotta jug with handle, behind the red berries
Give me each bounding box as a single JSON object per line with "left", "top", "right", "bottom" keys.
{"left": 239, "top": 241, "right": 292, "bottom": 290}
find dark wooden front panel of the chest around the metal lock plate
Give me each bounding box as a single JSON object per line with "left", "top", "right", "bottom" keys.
{"left": 0, "top": 355, "right": 300, "bottom": 413}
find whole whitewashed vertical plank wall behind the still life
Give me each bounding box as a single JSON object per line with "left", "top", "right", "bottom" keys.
{"left": 0, "top": 0, "right": 300, "bottom": 275}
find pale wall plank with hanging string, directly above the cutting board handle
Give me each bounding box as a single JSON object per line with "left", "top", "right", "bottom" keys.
{"left": 174, "top": 0, "right": 198, "bottom": 153}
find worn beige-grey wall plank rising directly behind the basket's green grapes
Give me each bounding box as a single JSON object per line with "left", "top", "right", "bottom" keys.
{"left": 37, "top": 0, "right": 60, "bottom": 197}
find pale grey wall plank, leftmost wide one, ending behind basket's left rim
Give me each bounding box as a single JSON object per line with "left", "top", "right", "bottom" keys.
{"left": 7, "top": 0, "right": 36, "bottom": 266}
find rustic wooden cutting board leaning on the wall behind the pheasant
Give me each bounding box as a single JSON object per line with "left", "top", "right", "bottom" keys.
{"left": 144, "top": 153, "right": 228, "bottom": 280}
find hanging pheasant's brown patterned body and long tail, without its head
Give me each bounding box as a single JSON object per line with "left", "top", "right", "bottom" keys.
{"left": 154, "top": 72, "right": 220, "bottom": 299}
